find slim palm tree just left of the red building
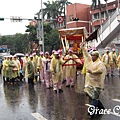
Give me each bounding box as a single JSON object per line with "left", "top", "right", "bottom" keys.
{"left": 58, "top": 0, "right": 72, "bottom": 28}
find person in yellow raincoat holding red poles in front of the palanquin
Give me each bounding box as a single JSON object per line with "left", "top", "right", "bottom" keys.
{"left": 64, "top": 49, "right": 82, "bottom": 87}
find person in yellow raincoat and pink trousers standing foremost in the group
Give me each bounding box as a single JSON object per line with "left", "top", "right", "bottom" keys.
{"left": 50, "top": 51, "right": 64, "bottom": 93}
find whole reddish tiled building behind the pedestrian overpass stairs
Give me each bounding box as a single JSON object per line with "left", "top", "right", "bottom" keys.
{"left": 66, "top": 0, "right": 120, "bottom": 48}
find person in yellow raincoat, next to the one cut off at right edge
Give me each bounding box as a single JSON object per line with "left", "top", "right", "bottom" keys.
{"left": 109, "top": 48, "right": 117, "bottom": 76}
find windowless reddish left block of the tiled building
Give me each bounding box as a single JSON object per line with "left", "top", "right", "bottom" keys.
{"left": 66, "top": 3, "right": 91, "bottom": 32}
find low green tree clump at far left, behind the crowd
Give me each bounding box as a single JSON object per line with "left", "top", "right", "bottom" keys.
{"left": 0, "top": 33, "right": 29, "bottom": 54}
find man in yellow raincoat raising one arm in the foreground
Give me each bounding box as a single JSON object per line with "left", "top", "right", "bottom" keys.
{"left": 82, "top": 43, "right": 106, "bottom": 114}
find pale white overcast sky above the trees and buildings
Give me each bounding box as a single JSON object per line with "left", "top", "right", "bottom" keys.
{"left": 0, "top": 0, "right": 114, "bottom": 35}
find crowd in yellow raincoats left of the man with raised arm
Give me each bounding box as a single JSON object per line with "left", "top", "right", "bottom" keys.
{"left": 2, "top": 49, "right": 82, "bottom": 93}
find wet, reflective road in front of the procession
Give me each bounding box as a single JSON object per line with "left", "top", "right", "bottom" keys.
{"left": 0, "top": 72, "right": 120, "bottom": 120}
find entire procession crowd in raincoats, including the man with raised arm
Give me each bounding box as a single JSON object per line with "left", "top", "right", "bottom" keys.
{"left": 2, "top": 44, "right": 120, "bottom": 116}
